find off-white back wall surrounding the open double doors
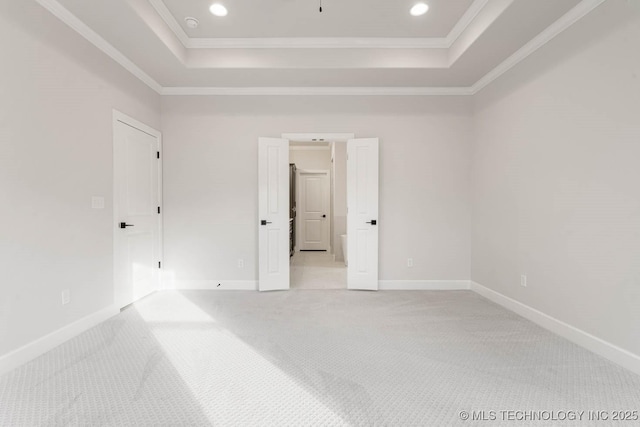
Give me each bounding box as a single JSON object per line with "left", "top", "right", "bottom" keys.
{"left": 162, "top": 96, "right": 471, "bottom": 286}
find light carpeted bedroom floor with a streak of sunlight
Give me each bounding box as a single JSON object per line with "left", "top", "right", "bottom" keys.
{"left": 0, "top": 290, "right": 640, "bottom": 426}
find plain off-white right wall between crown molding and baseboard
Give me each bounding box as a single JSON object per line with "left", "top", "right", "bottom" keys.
{"left": 472, "top": 1, "right": 640, "bottom": 354}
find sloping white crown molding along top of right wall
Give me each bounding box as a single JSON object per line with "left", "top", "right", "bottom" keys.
{"left": 470, "top": 0, "right": 606, "bottom": 95}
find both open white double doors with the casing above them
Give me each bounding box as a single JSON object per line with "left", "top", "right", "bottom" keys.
{"left": 258, "top": 134, "right": 379, "bottom": 291}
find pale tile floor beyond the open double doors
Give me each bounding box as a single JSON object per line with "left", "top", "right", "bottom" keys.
{"left": 290, "top": 251, "right": 347, "bottom": 289}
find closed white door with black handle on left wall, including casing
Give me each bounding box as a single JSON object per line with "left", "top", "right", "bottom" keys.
{"left": 113, "top": 112, "right": 162, "bottom": 308}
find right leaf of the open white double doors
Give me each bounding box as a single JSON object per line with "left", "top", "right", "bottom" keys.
{"left": 347, "top": 138, "right": 379, "bottom": 290}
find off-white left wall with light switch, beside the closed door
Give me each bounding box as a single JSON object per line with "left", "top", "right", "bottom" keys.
{"left": 0, "top": 1, "right": 160, "bottom": 356}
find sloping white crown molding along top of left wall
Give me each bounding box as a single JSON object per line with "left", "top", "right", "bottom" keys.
{"left": 36, "top": 0, "right": 162, "bottom": 93}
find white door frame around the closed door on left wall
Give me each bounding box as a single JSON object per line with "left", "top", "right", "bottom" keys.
{"left": 111, "top": 108, "right": 164, "bottom": 308}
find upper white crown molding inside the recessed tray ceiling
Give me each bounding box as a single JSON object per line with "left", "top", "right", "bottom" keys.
{"left": 149, "top": 0, "right": 489, "bottom": 49}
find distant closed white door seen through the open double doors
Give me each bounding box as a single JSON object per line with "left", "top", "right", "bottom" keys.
{"left": 296, "top": 170, "right": 331, "bottom": 251}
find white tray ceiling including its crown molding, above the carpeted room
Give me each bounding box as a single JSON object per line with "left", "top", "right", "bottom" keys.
{"left": 36, "top": 0, "right": 605, "bottom": 95}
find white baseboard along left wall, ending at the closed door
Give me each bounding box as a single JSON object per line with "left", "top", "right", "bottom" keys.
{"left": 0, "top": 305, "right": 120, "bottom": 375}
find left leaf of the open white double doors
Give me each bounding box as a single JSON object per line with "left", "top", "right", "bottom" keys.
{"left": 258, "top": 138, "right": 289, "bottom": 291}
